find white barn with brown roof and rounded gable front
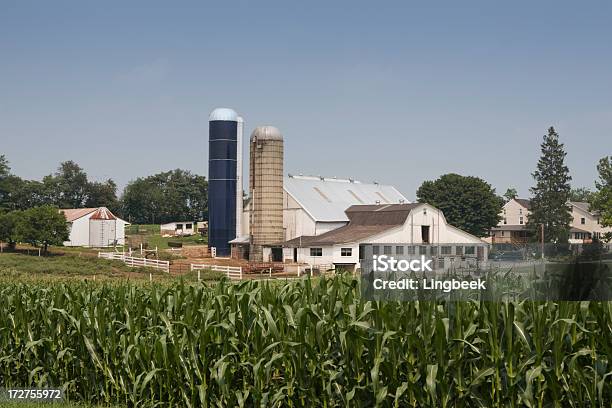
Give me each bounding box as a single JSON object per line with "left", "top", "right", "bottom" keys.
{"left": 280, "top": 203, "right": 488, "bottom": 269}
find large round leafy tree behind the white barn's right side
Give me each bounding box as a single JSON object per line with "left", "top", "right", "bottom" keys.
{"left": 417, "top": 173, "right": 503, "bottom": 237}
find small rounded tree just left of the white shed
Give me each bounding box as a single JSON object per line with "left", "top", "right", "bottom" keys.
{"left": 14, "top": 206, "right": 69, "bottom": 254}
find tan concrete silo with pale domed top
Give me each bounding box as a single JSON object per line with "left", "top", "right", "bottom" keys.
{"left": 249, "top": 126, "right": 284, "bottom": 261}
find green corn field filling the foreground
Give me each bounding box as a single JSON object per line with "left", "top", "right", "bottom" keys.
{"left": 0, "top": 277, "right": 612, "bottom": 407}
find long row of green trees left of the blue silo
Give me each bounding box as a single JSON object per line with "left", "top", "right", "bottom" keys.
{"left": 0, "top": 155, "right": 208, "bottom": 224}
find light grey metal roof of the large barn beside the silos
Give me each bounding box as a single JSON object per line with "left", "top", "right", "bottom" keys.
{"left": 284, "top": 176, "right": 409, "bottom": 222}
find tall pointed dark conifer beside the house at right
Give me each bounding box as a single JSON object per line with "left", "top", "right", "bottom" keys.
{"left": 527, "top": 127, "right": 572, "bottom": 243}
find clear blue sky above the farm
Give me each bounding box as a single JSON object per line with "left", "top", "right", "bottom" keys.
{"left": 0, "top": 0, "right": 612, "bottom": 199}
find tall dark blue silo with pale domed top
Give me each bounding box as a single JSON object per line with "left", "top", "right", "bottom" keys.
{"left": 208, "top": 108, "right": 242, "bottom": 256}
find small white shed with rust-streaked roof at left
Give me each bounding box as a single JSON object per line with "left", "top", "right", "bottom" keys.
{"left": 60, "top": 207, "right": 129, "bottom": 248}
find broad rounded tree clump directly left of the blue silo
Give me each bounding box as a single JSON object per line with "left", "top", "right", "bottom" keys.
{"left": 122, "top": 169, "right": 208, "bottom": 224}
